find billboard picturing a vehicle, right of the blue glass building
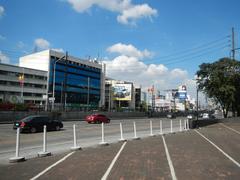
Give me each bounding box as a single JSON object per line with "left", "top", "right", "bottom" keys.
{"left": 113, "top": 84, "right": 132, "bottom": 101}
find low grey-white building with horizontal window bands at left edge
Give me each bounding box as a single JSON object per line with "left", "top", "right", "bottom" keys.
{"left": 0, "top": 63, "right": 47, "bottom": 104}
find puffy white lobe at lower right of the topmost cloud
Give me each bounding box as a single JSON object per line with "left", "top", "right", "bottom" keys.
{"left": 117, "top": 4, "right": 157, "bottom": 25}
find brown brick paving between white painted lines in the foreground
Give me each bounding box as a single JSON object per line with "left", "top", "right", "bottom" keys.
{"left": 0, "top": 122, "right": 240, "bottom": 180}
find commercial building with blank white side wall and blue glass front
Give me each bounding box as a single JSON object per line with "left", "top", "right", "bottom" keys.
{"left": 19, "top": 50, "right": 105, "bottom": 108}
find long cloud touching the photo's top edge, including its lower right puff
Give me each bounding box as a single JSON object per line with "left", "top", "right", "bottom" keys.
{"left": 67, "top": 0, "right": 157, "bottom": 24}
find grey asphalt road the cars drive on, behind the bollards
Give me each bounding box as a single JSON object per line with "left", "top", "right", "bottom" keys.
{"left": 0, "top": 118, "right": 185, "bottom": 164}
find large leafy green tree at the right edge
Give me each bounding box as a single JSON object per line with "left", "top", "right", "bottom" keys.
{"left": 196, "top": 58, "right": 240, "bottom": 117}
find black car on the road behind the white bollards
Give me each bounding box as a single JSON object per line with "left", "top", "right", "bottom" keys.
{"left": 13, "top": 115, "right": 63, "bottom": 133}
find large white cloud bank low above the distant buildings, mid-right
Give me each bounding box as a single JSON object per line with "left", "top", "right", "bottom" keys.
{"left": 104, "top": 55, "right": 188, "bottom": 90}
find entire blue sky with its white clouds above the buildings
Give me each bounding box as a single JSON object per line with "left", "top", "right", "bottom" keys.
{"left": 0, "top": 0, "right": 240, "bottom": 98}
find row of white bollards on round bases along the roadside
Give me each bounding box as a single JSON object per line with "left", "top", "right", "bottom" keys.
{"left": 9, "top": 119, "right": 189, "bottom": 162}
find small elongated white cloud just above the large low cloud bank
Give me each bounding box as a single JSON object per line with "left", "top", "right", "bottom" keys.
{"left": 107, "top": 43, "right": 153, "bottom": 59}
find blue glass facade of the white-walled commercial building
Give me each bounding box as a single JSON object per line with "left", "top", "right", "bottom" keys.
{"left": 49, "top": 57, "right": 101, "bottom": 107}
